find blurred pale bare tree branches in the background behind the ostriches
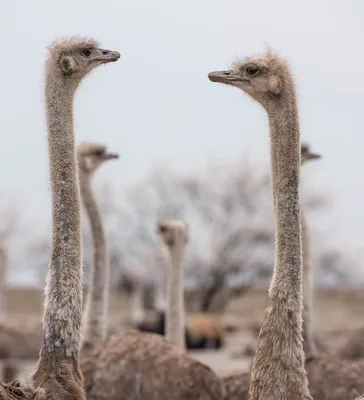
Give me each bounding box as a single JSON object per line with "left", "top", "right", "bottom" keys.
{"left": 24, "top": 159, "right": 358, "bottom": 304}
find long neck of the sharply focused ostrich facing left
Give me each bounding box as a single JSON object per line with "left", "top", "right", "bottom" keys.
{"left": 250, "top": 92, "right": 310, "bottom": 400}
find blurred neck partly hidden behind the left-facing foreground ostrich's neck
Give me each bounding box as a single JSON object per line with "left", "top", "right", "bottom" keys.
{"left": 301, "top": 209, "right": 317, "bottom": 358}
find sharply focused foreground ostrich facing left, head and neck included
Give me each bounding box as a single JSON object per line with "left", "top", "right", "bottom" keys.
{"left": 208, "top": 52, "right": 312, "bottom": 400}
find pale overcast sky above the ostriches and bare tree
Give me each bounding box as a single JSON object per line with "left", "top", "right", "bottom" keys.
{"left": 0, "top": 0, "right": 364, "bottom": 282}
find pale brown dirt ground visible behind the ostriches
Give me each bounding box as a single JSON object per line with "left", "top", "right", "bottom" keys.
{"left": 7, "top": 288, "right": 364, "bottom": 378}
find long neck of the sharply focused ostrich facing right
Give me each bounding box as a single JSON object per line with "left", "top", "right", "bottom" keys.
{"left": 40, "top": 78, "right": 82, "bottom": 360}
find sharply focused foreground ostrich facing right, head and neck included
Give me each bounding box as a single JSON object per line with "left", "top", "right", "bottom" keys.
{"left": 0, "top": 38, "right": 120, "bottom": 400}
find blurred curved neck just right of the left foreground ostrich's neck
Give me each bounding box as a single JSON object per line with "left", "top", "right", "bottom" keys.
{"left": 80, "top": 169, "right": 109, "bottom": 344}
